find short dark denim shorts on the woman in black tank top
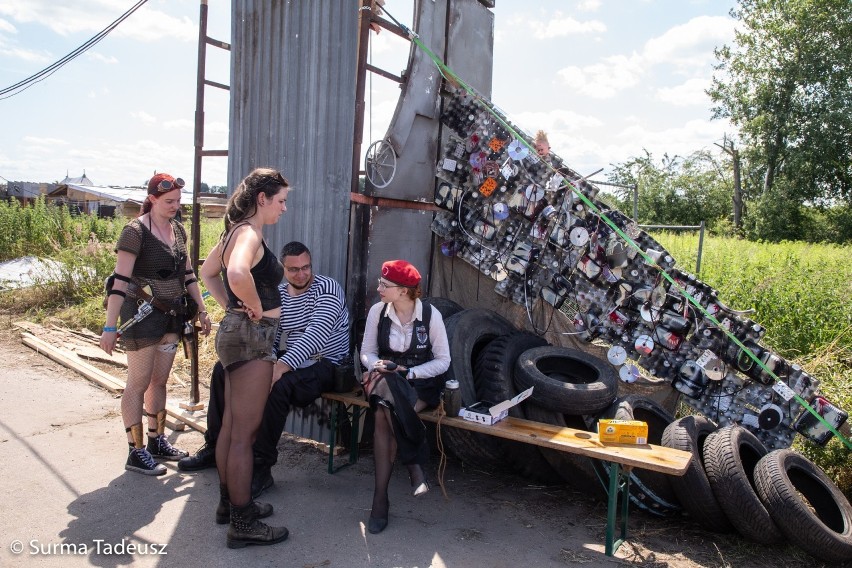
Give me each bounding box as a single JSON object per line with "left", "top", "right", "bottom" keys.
{"left": 216, "top": 312, "right": 278, "bottom": 370}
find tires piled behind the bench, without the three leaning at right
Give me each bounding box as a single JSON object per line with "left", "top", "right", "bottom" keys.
{"left": 430, "top": 306, "right": 680, "bottom": 515}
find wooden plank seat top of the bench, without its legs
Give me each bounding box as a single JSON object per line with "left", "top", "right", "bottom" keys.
{"left": 322, "top": 391, "right": 692, "bottom": 475}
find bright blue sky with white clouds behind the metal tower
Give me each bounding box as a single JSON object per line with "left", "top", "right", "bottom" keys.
{"left": 0, "top": 0, "right": 734, "bottom": 189}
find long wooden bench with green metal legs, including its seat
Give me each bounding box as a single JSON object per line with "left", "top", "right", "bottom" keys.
{"left": 322, "top": 389, "right": 692, "bottom": 556}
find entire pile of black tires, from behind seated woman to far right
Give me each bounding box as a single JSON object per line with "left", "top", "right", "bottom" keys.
{"left": 429, "top": 304, "right": 852, "bottom": 562}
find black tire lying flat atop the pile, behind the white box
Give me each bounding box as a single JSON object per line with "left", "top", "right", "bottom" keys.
{"left": 515, "top": 345, "right": 618, "bottom": 416}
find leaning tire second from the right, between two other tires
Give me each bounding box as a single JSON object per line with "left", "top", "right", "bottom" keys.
{"left": 704, "top": 424, "right": 784, "bottom": 544}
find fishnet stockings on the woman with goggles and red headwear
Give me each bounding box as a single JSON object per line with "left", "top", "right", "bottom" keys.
{"left": 121, "top": 333, "right": 178, "bottom": 442}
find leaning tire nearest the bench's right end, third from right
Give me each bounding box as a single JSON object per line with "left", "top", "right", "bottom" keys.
{"left": 661, "top": 416, "right": 733, "bottom": 533}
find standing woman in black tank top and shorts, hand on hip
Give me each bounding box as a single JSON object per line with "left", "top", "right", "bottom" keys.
{"left": 201, "top": 168, "right": 290, "bottom": 548}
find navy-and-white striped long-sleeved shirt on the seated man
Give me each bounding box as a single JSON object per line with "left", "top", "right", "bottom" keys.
{"left": 275, "top": 274, "right": 349, "bottom": 369}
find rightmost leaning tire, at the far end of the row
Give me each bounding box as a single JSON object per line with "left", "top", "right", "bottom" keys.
{"left": 754, "top": 449, "right": 852, "bottom": 562}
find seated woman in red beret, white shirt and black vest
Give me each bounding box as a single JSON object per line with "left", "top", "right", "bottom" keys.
{"left": 361, "top": 260, "right": 450, "bottom": 534}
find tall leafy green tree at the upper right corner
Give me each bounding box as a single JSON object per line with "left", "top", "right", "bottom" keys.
{"left": 708, "top": 0, "right": 852, "bottom": 204}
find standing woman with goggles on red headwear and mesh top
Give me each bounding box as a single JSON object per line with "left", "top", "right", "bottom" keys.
{"left": 100, "top": 174, "right": 210, "bottom": 475}
